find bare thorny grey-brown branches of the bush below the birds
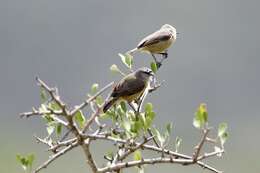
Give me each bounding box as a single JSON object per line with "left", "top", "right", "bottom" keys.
{"left": 20, "top": 78, "right": 224, "bottom": 173}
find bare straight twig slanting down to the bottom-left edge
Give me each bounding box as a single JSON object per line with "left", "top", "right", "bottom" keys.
{"left": 34, "top": 142, "right": 78, "bottom": 173}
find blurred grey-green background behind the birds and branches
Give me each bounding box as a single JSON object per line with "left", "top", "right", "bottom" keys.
{"left": 0, "top": 0, "right": 260, "bottom": 173}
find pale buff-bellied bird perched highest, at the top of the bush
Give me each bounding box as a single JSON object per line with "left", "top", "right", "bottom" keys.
{"left": 127, "top": 24, "right": 178, "bottom": 67}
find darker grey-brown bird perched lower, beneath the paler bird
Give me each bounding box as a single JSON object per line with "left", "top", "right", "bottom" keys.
{"left": 103, "top": 67, "right": 154, "bottom": 113}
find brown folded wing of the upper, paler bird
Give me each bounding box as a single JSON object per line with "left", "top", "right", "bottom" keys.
{"left": 137, "top": 30, "right": 171, "bottom": 49}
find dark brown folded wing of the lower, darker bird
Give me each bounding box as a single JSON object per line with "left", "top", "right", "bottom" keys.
{"left": 111, "top": 77, "right": 145, "bottom": 97}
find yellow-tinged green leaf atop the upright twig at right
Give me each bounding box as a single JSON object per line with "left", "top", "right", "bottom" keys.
{"left": 193, "top": 103, "right": 208, "bottom": 129}
